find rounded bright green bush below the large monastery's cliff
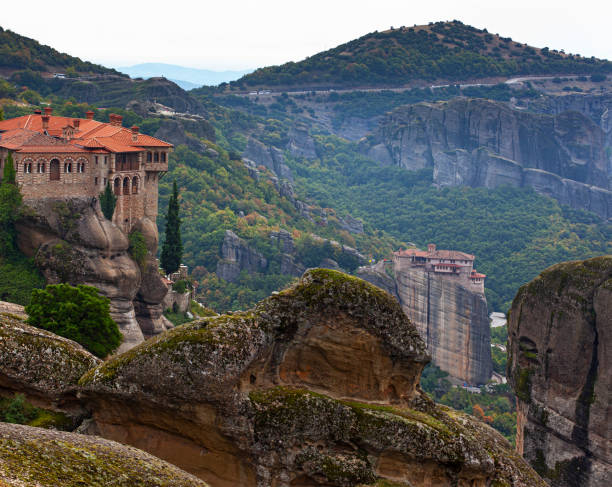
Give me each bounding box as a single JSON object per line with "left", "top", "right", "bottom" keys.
{"left": 25, "top": 284, "right": 121, "bottom": 357}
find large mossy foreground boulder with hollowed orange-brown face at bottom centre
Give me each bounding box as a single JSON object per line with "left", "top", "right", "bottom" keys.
{"left": 71, "top": 269, "right": 544, "bottom": 487}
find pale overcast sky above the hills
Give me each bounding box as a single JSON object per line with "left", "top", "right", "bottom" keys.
{"left": 0, "top": 0, "right": 612, "bottom": 70}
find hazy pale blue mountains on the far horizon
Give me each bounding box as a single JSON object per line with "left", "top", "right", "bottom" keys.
{"left": 117, "top": 63, "right": 253, "bottom": 90}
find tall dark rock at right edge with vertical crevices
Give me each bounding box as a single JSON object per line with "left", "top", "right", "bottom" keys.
{"left": 508, "top": 257, "right": 612, "bottom": 487}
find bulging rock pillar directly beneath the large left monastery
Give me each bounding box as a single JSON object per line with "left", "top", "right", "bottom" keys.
{"left": 17, "top": 198, "right": 168, "bottom": 351}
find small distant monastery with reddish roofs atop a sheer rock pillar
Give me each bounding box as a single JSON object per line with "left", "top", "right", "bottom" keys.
{"left": 393, "top": 244, "right": 487, "bottom": 294}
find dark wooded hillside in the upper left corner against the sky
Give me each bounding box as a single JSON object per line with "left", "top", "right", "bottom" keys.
{"left": 0, "top": 27, "right": 120, "bottom": 75}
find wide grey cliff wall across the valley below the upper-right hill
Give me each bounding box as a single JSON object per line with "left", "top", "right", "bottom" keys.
{"left": 364, "top": 98, "right": 612, "bottom": 218}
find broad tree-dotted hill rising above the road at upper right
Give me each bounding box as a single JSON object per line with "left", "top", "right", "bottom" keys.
{"left": 232, "top": 21, "right": 612, "bottom": 88}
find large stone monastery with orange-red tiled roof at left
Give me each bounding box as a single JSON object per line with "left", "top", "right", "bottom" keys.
{"left": 0, "top": 108, "right": 173, "bottom": 232}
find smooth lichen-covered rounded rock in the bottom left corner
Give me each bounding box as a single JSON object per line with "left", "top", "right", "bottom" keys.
{"left": 0, "top": 423, "right": 206, "bottom": 487}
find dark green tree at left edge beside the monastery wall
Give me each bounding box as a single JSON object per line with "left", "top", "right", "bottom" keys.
{"left": 0, "top": 152, "right": 22, "bottom": 255}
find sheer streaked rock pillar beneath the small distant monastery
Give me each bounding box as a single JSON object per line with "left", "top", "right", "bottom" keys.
{"left": 357, "top": 262, "right": 492, "bottom": 384}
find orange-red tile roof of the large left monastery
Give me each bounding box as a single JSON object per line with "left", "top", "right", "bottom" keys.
{"left": 0, "top": 114, "right": 172, "bottom": 152}
